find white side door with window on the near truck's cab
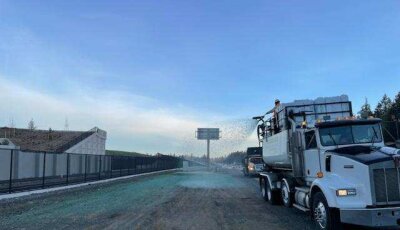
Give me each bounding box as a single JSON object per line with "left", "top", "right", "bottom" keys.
{"left": 304, "top": 130, "right": 321, "bottom": 179}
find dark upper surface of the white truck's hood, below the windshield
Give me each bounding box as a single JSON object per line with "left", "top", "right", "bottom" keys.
{"left": 326, "top": 145, "right": 399, "bottom": 165}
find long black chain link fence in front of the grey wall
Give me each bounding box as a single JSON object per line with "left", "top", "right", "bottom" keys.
{"left": 0, "top": 149, "right": 182, "bottom": 193}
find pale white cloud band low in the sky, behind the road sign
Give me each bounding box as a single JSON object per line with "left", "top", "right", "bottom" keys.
{"left": 0, "top": 77, "right": 255, "bottom": 156}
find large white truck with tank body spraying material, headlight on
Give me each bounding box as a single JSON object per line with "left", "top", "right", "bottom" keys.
{"left": 254, "top": 95, "right": 400, "bottom": 229}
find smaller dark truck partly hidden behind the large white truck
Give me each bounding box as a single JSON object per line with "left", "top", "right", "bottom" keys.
{"left": 243, "top": 147, "right": 264, "bottom": 176}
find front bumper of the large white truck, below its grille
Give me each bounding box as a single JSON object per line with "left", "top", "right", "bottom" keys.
{"left": 340, "top": 207, "right": 400, "bottom": 227}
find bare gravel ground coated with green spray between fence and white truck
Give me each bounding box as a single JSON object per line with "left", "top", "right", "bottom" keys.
{"left": 0, "top": 170, "right": 368, "bottom": 230}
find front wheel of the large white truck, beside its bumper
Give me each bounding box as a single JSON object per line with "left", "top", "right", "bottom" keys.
{"left": 312, "top": 192, "right": 342, "bottom": 230}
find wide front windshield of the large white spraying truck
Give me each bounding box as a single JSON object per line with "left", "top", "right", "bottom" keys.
{"left": 319, "top": 124, "right": 382, "bottom": 146}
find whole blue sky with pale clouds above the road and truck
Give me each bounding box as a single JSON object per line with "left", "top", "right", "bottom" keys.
{"left": 0, "top": 0, "right": 400, "bottom": 153}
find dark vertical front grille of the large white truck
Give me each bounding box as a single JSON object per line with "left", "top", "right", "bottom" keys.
{"left": 373, "top": 168, "right": 400, "bottom": 204}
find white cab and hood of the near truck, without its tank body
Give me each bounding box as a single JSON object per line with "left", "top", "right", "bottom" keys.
{"left": 301, "top": 119, "right": 400, "bottom": 227}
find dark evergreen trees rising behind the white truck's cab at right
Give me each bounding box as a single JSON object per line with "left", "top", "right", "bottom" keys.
{"left": 359, "top": 92, "right": 400, "bottom": 121}
